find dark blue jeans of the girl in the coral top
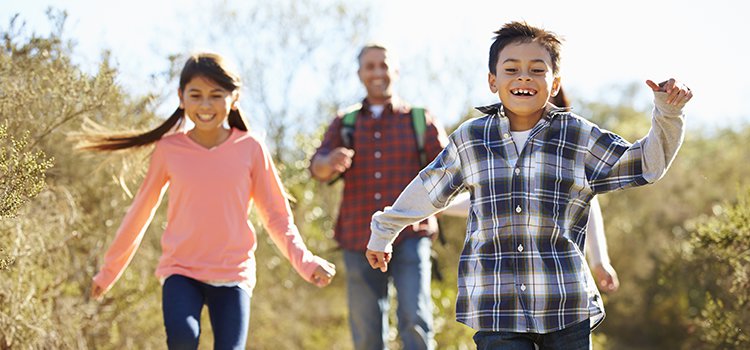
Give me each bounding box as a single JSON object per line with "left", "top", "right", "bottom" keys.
{"left": 162, "top": 275, "right": 250, "bottom": 350}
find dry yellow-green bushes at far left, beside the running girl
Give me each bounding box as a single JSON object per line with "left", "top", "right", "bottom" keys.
{"left": 0, "top": 11, "right": 159, "bottom": 348}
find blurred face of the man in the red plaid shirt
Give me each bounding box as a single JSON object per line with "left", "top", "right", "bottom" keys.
{"left": 357, "top": 48, "right": 398, "bottom": 104}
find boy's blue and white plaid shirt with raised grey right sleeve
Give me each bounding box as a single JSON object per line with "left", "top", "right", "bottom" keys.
{"left": 418, "top": 101, "right": 683, "bottom": 333}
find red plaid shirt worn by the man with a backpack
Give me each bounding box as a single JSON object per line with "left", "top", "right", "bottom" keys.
{"left": 313, "top": 98, "right": 448, "bottom": 251}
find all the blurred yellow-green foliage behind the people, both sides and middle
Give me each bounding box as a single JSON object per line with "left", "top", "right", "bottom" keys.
{"left": 0, "top": 6, "right": 750, "bottom": 349}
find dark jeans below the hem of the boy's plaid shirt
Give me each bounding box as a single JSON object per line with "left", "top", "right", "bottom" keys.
{"left": 474, "top": 320, "right": 591, "bottom": 350}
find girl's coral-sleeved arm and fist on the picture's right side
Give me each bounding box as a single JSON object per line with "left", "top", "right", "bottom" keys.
{"left": 251, "top": 141, "right": 332, "bottom": 283}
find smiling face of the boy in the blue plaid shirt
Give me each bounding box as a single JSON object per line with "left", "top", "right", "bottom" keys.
{"left": 488, "top": 41, "right": 560, "bottom": 122}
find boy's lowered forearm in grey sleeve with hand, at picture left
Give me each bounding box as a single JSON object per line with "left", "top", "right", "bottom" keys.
{"left": 365, "top": 176, "right": 450, "bottom": 272}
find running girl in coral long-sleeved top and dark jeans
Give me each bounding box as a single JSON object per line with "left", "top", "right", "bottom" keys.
{"left": 82, "top": 53, "right": 335, "bottom": 349}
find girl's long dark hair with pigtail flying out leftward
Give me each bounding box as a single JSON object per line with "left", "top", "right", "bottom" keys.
{"left": 79, "top": 53, "right": 247, "bottom": 151}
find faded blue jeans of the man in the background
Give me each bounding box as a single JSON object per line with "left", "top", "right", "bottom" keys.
{"left": 344, "top": 237, "right": 435, "bottom": 350}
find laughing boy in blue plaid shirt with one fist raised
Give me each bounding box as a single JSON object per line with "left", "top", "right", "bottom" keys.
{"left": 365, "top": 22, "right": 692, "bottom": 349}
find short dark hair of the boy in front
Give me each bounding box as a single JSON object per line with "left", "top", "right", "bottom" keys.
{"left": 489, "top": 21, "right": 562, "bottom": 75}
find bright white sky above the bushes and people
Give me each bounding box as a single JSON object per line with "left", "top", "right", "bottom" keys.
{"left": 0, "top": 0, "right": 750, "bottom": 127}
